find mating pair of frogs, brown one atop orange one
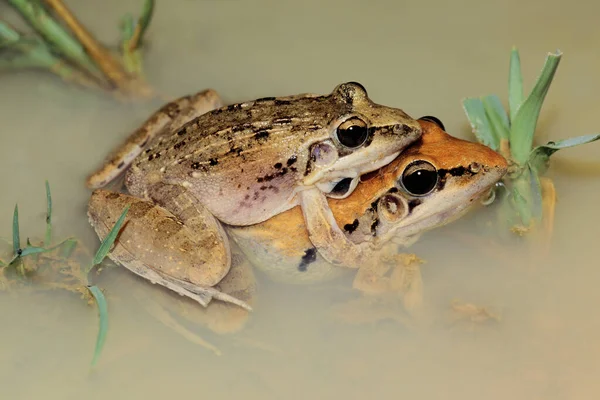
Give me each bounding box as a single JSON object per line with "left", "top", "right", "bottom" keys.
{"left": 88, "top": 83, "right": 506, "bottom": 308}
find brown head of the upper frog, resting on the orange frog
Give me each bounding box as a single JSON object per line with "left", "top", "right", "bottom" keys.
{"left": 304, "top": 82, "right": 421, "bottom": 198}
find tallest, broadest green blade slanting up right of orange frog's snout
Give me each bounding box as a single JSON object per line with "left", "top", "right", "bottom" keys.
{"left": 510, "top": 51, "right": 562, "bottom": 165}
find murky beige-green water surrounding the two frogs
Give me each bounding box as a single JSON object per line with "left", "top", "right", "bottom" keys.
{"left": 0, "top": 0, "right": 600, "bottom": 399}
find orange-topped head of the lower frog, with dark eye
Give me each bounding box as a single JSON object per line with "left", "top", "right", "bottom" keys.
{"left": 364, "top": 118, "right": 507, "bottom": 244}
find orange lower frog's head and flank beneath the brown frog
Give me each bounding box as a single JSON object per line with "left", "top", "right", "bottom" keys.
{"left": 226, "top": 121, "right": 507, "bottom": 291}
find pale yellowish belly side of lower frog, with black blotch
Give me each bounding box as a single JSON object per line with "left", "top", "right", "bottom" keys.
{"left": 227, "top": 224, "right": 350, "bottom": 284}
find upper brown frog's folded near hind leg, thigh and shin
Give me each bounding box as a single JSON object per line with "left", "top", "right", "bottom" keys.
{"left": 88, "top": 190, "right": 250, "bottom": 309}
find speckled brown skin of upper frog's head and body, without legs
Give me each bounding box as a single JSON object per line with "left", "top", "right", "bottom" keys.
{"left": 126, "top": 83, "right": 421, "bottom": 225}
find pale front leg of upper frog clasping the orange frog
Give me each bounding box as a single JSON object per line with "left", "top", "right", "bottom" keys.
{"left": 298, "top": 188, "right": 372, "bottom": 268}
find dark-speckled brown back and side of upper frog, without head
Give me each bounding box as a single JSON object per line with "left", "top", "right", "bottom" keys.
{"left": 127, "top": 94, "right": 336, "bottom": 224}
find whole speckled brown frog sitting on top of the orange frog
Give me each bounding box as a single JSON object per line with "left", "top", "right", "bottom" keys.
{"left": 88, "top": 82, "right": 421, "bottom": 307}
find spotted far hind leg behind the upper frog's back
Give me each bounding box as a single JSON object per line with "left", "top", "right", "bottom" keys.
{"left": 86, "top": 89, "right": 222, "bottom": 189}
